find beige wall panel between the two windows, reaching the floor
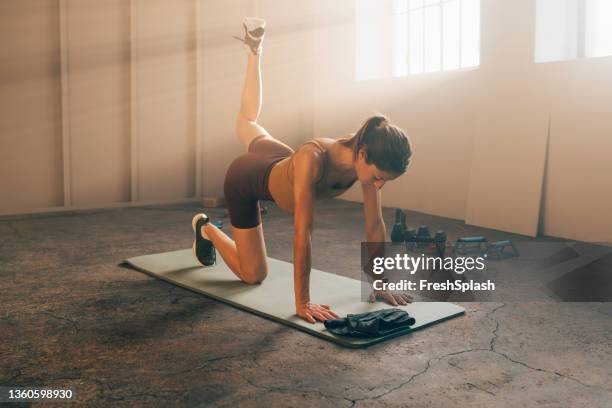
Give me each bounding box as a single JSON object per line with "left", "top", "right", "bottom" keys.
{"left": 465, "top": 0, "right": 549, "bottom": 236}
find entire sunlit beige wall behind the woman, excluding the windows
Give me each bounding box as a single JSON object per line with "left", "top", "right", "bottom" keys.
{"left": 0, "top": 0, "right": 612, "bottom": 242}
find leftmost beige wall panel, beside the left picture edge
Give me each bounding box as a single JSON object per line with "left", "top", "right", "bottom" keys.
{"left": 0, "top": 0, "right": 63, "bottom": 213}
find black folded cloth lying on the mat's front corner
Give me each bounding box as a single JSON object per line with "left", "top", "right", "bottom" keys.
{"left": 323, "top": 308, "right": 415, "bottom": 337}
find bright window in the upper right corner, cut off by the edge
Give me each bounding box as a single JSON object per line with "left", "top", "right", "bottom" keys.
{"left": 535, "top": 0, "right": 612, "bottom": 62}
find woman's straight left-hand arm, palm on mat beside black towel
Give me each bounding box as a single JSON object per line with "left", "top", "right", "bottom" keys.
{"left": 293, "top": 148, "right": 338, "bottom": 323}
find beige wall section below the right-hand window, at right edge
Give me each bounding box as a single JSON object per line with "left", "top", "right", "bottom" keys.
{"left": 541, "top": 57, "right": 612, "bottom": 243}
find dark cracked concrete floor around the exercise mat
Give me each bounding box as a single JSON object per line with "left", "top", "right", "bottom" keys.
{"left": 0, "top": 200, "right": 612, "bottom": 407}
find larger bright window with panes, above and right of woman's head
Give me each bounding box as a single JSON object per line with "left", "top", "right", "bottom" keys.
{"left": 356, "top": 0, "right": 480, "bottom": 79}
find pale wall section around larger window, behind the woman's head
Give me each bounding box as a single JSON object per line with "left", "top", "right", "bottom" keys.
{"left": 314, "top": 0, "right": 479, "bottom": 219}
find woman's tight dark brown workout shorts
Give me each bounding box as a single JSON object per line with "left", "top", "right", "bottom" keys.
{"left": 223, "top": 135, "right": 293, "bottom": 228}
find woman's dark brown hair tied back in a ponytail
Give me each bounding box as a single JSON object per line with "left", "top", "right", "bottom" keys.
{"left": 347, "top": 115, "right": 412, "bottom": 174}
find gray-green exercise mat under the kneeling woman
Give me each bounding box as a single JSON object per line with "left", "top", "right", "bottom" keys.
{"left": 125, "top": 249, "right": 465, "bottom": 348}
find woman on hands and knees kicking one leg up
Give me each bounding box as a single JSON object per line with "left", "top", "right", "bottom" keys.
{"left": 192, "top": 18, "right": 412, "bottom": 323}
